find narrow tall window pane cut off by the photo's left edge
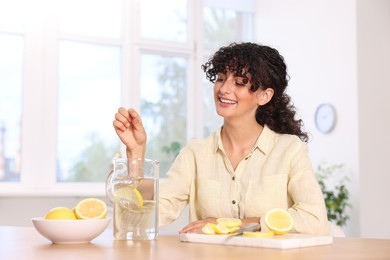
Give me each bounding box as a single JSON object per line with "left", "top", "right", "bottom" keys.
{"left": 0, "top": 34, "right": 23, "bottom": 181}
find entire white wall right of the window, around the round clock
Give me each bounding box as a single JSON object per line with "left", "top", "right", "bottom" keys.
{"left": 256, "top": 0, "right": 390, "bottom": 238}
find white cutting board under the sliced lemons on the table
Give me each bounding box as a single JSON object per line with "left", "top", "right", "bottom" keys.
{"left": 180, "top": 233, "right": 333, "bottom": 249}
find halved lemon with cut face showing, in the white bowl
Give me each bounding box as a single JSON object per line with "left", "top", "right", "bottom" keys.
{"left": 74, "top": 198, "right": 107, "bottom": 219}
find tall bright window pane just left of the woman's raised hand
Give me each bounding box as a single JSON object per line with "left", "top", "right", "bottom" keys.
{"left": 57, "top": 41, "right": 121, "bottom": 181}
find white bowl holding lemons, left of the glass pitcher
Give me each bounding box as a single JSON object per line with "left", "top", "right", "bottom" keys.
{"left": 31, "top": 217, "right": 110, "bottom": 244}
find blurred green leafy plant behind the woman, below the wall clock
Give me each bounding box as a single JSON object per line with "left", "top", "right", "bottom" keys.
{"left": 315, "top": 163, "right": 352, "bottom": 227}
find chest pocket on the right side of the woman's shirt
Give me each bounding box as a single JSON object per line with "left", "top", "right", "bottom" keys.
{"left": 246, "top": 174, "right": 288, "bottom": 216}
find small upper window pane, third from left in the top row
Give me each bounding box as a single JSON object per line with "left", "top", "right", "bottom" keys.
{"left": 140, "top": 0, "right": 188, "bottom": 42}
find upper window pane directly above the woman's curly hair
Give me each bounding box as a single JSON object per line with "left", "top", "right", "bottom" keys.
{"left": 203, "top": 6, "right": 253, "bottom": 50}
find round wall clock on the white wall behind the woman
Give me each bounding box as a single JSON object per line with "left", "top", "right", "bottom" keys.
{"left": 314, "top": 103, "right": 336, "bottom": 134}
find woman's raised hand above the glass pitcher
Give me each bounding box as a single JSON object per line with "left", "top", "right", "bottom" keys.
{"left": 113, "top": 107, "right": 147, "bottom": 159}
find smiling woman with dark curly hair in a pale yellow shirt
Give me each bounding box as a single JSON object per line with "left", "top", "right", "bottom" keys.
{"left": 113, "top": 43, "right": 328, "bottom": 234}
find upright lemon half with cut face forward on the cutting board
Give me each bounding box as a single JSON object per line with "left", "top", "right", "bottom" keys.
{"left": 265, "top": 208, "right": 293, "bottom": 235}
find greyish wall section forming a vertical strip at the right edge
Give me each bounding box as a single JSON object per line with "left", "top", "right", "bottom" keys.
{"left": 357, "top": 0, "right": 390, "bottom": 238}
